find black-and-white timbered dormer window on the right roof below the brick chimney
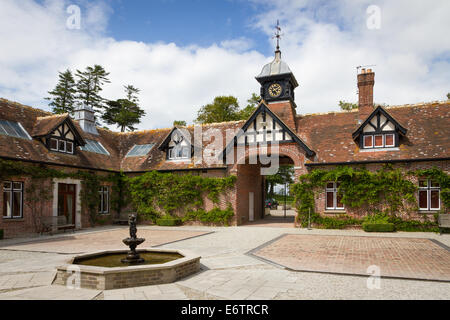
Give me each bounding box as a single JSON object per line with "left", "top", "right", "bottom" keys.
{"left": 353, "top": 107, "right": 407, "bottom": 151}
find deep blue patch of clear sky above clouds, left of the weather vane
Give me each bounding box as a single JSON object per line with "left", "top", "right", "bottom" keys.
{"left": 107, "top": 0, "right": 275, "bottom": 54}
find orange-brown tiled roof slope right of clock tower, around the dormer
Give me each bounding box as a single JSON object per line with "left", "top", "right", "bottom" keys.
{"left": 297, "top": 101, "right": 450, "bottom": 163}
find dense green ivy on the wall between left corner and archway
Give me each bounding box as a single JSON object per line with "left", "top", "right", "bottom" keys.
{"left": 126, "top": 171, "right": 236, "bottom": 220}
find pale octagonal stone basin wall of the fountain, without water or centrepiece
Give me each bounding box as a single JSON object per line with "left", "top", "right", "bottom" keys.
{"left": 53, "top": 249, "right": 200, "bottom": 290}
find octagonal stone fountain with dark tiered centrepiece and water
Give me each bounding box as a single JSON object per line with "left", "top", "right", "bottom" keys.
{"left": 53, "top": 215, "right": 200, "bottom": 290}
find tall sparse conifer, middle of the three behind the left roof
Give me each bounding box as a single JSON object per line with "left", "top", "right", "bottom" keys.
{"left": 76, "top": 65, "right": 110, "bottom": 112}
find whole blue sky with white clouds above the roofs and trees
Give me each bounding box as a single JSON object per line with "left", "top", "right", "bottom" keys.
{"left": 0, "top": 0, "right": 450, "bottom": 129}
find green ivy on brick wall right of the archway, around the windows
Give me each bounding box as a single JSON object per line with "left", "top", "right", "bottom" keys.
{"left": 292, "top": 165, "right": 450, "bottom": 229}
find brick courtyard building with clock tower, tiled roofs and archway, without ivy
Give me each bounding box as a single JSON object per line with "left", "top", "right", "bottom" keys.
{"left": 0, "top": 49, "right": 450, "bottom": 237}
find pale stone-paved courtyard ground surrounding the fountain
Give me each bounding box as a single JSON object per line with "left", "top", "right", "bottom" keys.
{"left": 0, "top": 225, "right": 450, "bottom": 300}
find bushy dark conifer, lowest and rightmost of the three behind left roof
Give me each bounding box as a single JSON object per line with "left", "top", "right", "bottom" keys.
{"left": 102, "top": 85, "right": 145, "bottom": 132}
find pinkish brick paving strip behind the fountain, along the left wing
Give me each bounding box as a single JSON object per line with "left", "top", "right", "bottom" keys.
{"left": 2, "top": 228, "right": 208, "bottom": 254}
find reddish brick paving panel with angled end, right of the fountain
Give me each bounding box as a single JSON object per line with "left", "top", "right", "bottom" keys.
{"left": 252, "top": 234, "right": 450, "bottom": 282}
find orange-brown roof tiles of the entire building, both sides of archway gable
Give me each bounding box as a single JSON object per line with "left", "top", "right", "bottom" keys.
{"left": 0, "top": 99, "right": 450, "bottom": 172}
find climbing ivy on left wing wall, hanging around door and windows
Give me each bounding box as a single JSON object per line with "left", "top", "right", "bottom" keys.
{"left": 0, "top": 159, "right": 120, "bottom": 225}
